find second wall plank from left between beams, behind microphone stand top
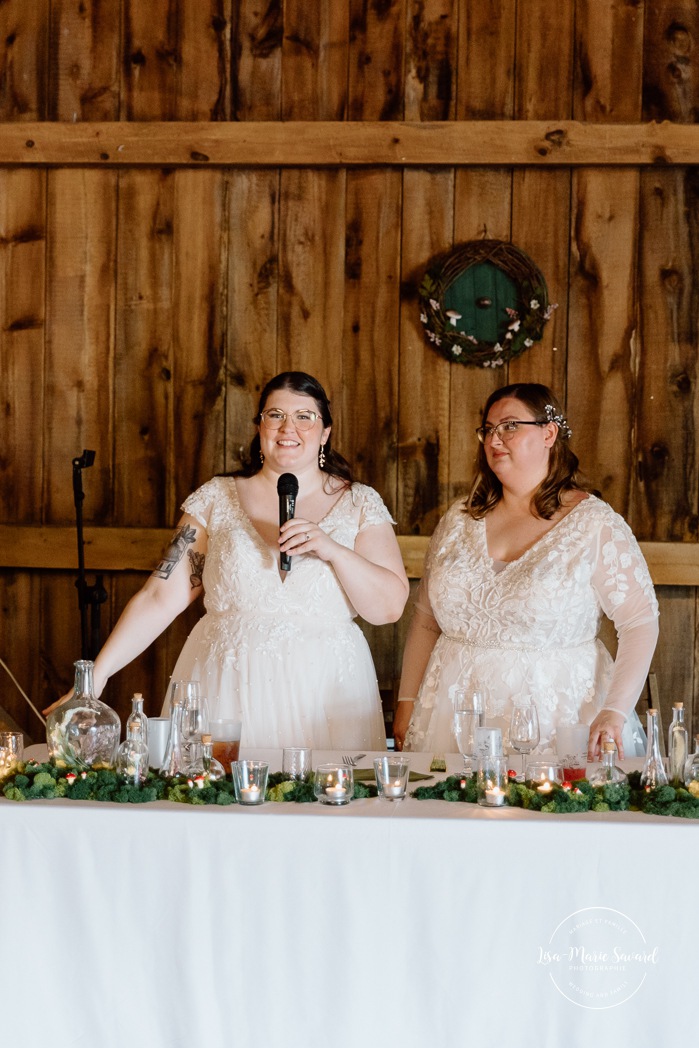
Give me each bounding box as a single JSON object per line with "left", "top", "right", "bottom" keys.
{"left": 44, "top": 169, "right": 116, "bottom": 524}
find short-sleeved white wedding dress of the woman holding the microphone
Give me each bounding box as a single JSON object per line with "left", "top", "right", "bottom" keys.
{"left": 166, "top": 477, "right": 392, "bottom": 750}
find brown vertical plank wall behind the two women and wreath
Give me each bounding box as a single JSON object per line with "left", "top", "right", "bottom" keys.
{"left": 0, "top": 0, "right": 699, "bottom": 735}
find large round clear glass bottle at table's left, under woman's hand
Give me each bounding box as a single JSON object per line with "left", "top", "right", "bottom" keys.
{"left": 46, "top": 659, "right": 122, "bottom": 771}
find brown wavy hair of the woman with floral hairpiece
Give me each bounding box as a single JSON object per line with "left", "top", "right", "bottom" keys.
{"left": 464, "top": 383, "right": 597, "bottom": 520}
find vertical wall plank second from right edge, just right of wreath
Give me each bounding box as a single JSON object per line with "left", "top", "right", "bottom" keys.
{"left": 568, "top": 2, "right": 643, "bottom": 515}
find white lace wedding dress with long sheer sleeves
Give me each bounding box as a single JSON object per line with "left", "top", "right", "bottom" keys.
{"left": 405, "top": 496, "right": 658, "bottom": 757}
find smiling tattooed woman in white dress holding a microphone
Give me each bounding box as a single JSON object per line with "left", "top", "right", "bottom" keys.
{"left": 51, "top": 371, "right": 409, "bottom": 750}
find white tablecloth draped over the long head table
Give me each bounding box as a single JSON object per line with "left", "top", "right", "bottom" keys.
{"left": 0, "top": 751, "right": 699, "bottom": 1048}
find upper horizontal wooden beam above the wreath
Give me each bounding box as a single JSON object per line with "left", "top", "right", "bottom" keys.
{"left": 0, "top": 121, "right": 699, "bottom": 168}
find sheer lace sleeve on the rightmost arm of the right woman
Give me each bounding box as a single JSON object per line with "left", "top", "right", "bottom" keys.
{"left": 592, "top": 510, "right": 658, "bottom": 715}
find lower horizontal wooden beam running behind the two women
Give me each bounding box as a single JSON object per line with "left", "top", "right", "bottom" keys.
{"left": 0, "top": 524, "right": 699, "bottom": 586}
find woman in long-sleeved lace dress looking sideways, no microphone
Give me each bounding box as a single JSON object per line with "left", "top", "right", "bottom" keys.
{"left": 394, "top": 383, "right": 658, "bottom": 760}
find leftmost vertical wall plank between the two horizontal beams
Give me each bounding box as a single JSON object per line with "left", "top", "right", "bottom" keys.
{"left": 0, "top": 170, "right": 46, "bottom": 523}
